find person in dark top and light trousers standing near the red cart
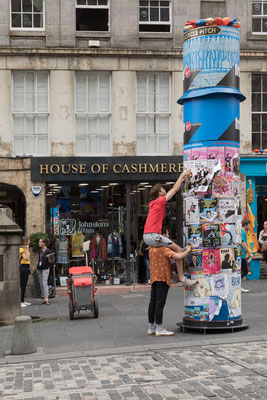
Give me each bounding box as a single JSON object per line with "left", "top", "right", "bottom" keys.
{"left": 37, "top": 238, "right": 54, "bottom": 305}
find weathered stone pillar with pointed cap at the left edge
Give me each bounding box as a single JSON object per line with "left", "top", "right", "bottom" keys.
{"left": 0, "top": 212, "right": 22, "bottom": 325}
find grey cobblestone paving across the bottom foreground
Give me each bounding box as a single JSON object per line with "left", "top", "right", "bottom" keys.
{"left": 0, "top": 341, "right": 267, "bottom": 400}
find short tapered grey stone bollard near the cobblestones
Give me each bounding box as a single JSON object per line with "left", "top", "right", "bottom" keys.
{"left": 10, "top": 315, "right": 37, "bottom": 355}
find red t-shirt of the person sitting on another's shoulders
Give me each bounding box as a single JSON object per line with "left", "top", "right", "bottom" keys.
{"left": 144, "top": 196, "right": 166, "bottom": 233}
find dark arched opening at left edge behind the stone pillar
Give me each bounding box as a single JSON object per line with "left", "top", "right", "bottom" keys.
{"left": 0, "top": 183, "right": 26, "bottom": 232}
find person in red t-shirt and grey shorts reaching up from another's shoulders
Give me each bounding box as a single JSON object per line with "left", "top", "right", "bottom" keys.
{"left": 143, "top": 171, "right": 196, "bottom": 286}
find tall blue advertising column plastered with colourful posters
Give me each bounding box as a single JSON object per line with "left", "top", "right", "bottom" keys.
{"left": 178, "top": 18, "right": 248, "bottom": 328}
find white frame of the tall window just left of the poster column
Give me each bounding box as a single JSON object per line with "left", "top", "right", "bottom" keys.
{"left": 136, "top": 71, "right": 172, "bottom": 156}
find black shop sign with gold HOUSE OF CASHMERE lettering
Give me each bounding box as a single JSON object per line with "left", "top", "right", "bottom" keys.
{"left": 31, "top": 156, "right": 183, "bottom": 182}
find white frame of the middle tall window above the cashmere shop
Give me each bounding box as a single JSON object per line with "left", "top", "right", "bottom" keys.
{"left": 74, "top": 71, "right": 112, "bottom": 157}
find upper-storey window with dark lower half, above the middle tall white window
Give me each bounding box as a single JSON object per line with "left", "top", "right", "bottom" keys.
{"left": 76, "top": 0, "right": 109, "bottom": 32}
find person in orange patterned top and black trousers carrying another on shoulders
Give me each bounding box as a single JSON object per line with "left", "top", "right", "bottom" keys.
{"left": 148, "top": 230, "right": 194, "bottom": 337}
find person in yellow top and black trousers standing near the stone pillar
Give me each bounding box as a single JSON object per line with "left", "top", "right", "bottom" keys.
{"left": 19, "top": 236, "right": 31, "bottom": 307}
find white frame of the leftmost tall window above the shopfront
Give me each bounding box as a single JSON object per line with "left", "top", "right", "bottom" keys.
{"left": 11, "top": 70, "right": 51, "bottom": 156}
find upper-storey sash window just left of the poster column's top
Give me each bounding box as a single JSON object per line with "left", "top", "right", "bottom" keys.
{"left": 139, "top": 0, "right": 171, "bottom": 32}
